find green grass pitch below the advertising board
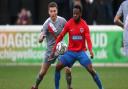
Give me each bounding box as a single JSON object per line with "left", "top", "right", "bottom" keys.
{"left": 0, "top": 66, "right": 128, "bottom": 89}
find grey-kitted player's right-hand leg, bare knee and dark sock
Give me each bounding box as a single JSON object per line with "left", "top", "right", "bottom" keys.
{"left": 64, "top": 67, "right": 72, "bottom": 89}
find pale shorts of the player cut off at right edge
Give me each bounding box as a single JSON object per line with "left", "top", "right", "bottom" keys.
{"left": 123, "top": 29, "right": 128, "bottom": 56}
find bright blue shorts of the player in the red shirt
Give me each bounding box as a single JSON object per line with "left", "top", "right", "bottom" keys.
{"left": 58, "top": 51, "right": 92, "bottom": 67}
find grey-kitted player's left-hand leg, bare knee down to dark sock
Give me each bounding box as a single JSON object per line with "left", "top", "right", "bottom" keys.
{"left": 32, "top": 63, "right": 51, "bottom": 89}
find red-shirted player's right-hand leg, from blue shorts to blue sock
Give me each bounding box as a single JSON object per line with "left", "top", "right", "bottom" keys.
{"left": 79, "top": 52, "right": 103, "bottom": 89}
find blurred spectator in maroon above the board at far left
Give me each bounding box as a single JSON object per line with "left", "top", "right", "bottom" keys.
{"left": 16, "top": 8, "right": 32, "bottom": 25}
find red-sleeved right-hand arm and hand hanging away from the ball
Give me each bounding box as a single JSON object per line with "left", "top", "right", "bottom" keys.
{"left": 85, "top": 24, "right": 94, "bottom": 58}
